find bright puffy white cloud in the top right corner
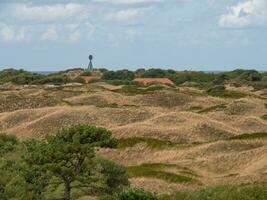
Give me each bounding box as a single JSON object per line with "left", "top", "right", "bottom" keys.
{"left": 219, "top": 0, "right": 267, "bottom": 28}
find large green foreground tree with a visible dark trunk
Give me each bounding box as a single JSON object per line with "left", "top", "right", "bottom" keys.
{"left": 25, "top": 125, "right": 117, "bottom": 200}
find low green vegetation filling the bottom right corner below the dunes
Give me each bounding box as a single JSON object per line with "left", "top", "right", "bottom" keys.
{"left": 160, "top": 185, "right": 267, "bottom": 200}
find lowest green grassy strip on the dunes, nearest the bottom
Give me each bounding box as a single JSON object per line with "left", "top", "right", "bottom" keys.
{"left": 126, "top": 163, "right": 196, "bottom": 183}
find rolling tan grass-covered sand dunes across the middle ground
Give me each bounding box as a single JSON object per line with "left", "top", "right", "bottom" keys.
{"left": 0, "top": 83, "right": 267, "bottom": 191}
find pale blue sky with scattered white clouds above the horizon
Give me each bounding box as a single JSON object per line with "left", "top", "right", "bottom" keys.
{"left": 0, "top": 0, "right": 267, "bottom": 71}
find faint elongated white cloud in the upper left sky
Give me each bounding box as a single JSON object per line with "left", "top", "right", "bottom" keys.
{"left": 12, "top": 3, "right": 84, "bottom": 22}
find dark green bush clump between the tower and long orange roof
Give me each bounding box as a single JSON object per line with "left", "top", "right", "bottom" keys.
{"left": 102, "top": 70, "right": 135, "bottom": 81}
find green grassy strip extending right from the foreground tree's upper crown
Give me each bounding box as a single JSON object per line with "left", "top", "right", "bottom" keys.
{"left": 118, "top": 137, "right": 188, "bottom": 149}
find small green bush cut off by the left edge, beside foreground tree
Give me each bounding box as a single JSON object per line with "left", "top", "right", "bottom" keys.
{"left": 0, "top": 133, "right": 18, "bottom": 156}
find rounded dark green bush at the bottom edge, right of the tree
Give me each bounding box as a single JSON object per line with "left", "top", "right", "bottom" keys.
{"left": 114, "top": 188, "right": 158, "bottom": 200}
